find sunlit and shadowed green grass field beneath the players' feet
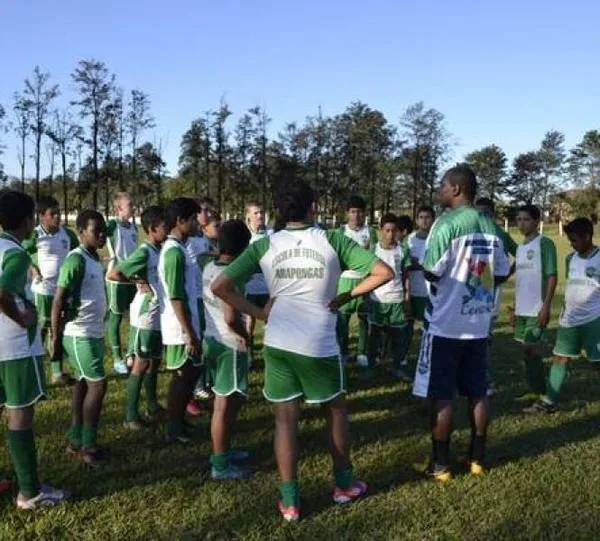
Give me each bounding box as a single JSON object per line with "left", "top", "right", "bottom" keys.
{"left": 0, "top": 229, "right": 600, "bottom": 541}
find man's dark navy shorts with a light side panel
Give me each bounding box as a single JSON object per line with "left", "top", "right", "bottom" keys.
{"left": 413, "top": 332, "right": 488, "bottom": 400}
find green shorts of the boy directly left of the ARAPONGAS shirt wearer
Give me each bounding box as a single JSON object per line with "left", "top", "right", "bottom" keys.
{"left": 202, "top": 338, "right": 248, "bottom": 396}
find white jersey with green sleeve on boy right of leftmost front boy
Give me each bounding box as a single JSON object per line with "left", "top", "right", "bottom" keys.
{"left": 58, "top": 246, "right": 106, "bottom": 338}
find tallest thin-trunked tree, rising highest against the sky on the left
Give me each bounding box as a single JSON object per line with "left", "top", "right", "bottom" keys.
{"left": 71, "top": 59, "right": 115, "bottom": 208}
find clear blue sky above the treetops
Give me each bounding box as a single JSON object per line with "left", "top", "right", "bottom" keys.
{"left": 0, "top": 0, "right": 600, "bottom": 175}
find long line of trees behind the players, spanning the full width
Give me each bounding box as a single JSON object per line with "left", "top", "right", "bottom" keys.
{"left": 0, "top": 59, "right": 600, "bottom": 224}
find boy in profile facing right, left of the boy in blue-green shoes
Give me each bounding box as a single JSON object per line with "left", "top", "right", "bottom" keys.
{"left": 158, "top": 197, "right": 202, "bottom": 443}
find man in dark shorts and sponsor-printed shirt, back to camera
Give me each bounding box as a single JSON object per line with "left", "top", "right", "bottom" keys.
{"left": 413, "top": 166, "right": 510, "bottom": 481}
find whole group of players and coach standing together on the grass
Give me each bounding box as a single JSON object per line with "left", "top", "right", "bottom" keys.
{"left": 0, "top": 166, "right": 600, "bottom": 521}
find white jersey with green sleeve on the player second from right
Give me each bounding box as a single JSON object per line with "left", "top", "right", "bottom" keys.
{"left": 515, "top": 235, "right": 557, "bottom": 317}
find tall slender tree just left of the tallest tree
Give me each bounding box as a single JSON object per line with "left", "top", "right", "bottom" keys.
{"left": 23, "top": 66, "right": 60, "bottom": 199}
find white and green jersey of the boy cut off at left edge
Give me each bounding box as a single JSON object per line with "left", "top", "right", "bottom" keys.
{"left": 0, "top": 233, "right": 44, "bottom": 362}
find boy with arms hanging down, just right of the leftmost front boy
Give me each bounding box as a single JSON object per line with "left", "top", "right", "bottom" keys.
{"left": 52, "top": 210, "right": 106, "bottom": 465}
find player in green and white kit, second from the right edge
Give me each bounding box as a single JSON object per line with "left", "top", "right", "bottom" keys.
{"left": 511, "top": 205, "right": 558, "bottom": 397}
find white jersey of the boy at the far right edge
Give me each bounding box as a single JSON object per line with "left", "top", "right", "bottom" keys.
{"left": 559, "top": 248, "right": 600, "bottom": 327}
